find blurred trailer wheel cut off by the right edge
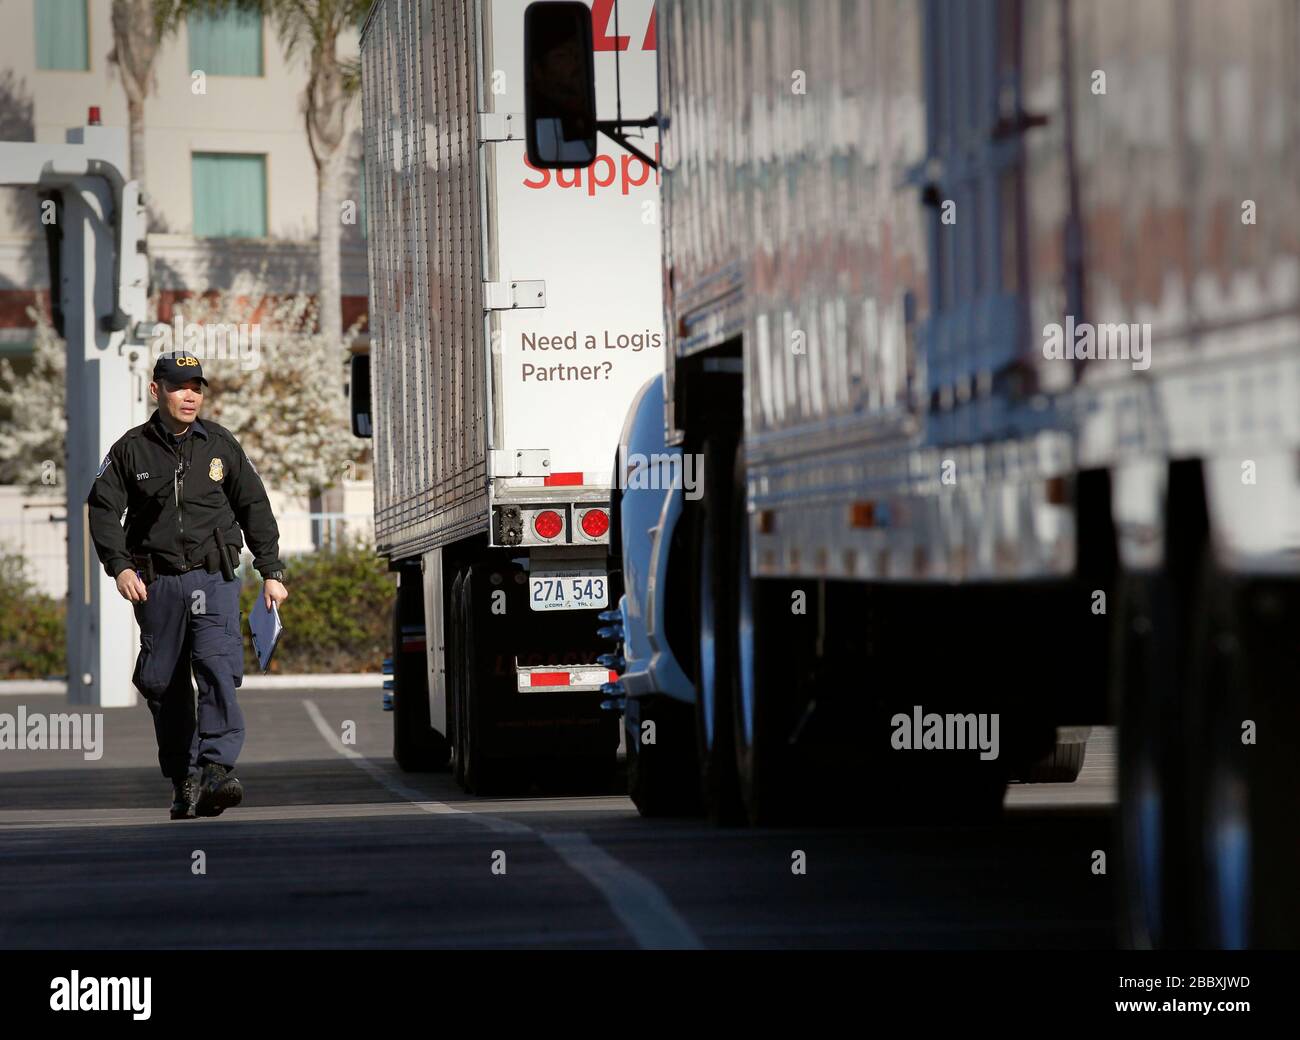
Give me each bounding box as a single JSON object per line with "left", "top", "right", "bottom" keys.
{"left": 1188, "top": 553, "right": 1300, "bottom": 949}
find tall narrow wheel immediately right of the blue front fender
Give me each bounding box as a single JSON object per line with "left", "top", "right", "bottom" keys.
{"left": 692, "top": 437, "right": 744, "bottom": 824}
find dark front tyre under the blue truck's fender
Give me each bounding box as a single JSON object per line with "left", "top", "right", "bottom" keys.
{"left": 624, "top": 697, "right": 701, "bottom": 816}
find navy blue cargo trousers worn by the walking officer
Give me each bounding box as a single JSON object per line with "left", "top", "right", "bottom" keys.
{"left": 131, "top": 568, "right": 244, "bottom": 780}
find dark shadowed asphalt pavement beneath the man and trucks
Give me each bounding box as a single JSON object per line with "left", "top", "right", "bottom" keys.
{"left": 0, "top": 689, "right": 1115, "bottom": 949}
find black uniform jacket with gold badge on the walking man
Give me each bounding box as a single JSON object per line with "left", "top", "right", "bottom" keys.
{"left": 86, "top": 411, "right": 283, "bottom": 579}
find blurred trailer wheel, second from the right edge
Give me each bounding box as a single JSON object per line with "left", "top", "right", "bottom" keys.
{"left": 1112, "top": 575, "right": 1190, "bottom": 949}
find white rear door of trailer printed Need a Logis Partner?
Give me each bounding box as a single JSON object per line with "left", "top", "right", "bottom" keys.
{"left": 484, "top": 0, "right": 664, "bottom": 485}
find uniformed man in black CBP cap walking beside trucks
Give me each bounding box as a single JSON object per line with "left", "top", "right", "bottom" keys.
{"left": 86, "top": 352, "right": 289, "bottom": 819}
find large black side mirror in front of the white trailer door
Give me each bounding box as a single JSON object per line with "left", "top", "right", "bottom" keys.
{"left": 524, "top": 0, "right": 597, "bottom": 170}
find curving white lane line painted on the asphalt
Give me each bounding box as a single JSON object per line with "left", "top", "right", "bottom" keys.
{"left": 303, "top": 699, "right": 703, "bottom": 949}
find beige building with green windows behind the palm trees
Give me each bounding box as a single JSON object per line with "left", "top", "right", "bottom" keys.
{"left": 0, "top": 0, "right": 367, "bottom": 367}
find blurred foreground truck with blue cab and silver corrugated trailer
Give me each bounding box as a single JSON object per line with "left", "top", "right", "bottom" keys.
{"left": 522, "top": 0, "right": 1300, "bottom": 946}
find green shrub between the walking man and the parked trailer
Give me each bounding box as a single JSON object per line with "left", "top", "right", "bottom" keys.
{"left": 239, "top": 541, "right": 397, "bottom": 675}
